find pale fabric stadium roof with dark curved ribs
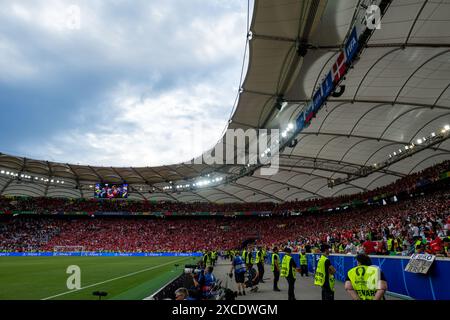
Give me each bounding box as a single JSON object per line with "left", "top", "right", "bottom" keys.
{"left": 0, "top": 0, "right": 450, "bottom": 202}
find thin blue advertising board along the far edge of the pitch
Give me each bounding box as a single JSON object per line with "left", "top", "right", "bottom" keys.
{"left": 0, "top": 252, "right": 202, "bottom": 257}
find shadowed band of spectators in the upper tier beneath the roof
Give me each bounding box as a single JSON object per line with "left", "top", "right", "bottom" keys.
{"left": 0, "top": 160, "right": 450, "bottom": 215}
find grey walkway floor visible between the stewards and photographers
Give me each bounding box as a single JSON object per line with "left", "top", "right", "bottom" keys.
{"left": 214, "top": 259, "right": 397, "bottom": 300}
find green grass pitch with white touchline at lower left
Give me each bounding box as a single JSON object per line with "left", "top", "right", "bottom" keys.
{"left": 0, "top": 257, "right": 198, "bottom": 300}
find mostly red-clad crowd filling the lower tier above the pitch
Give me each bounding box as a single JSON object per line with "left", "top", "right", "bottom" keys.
{"left": 0, "top": 190, "right": 450, "bottom": 254}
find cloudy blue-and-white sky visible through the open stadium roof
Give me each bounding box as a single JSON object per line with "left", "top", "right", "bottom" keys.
{"left": 0, "top": 0, "right": 247, "bottom": 166}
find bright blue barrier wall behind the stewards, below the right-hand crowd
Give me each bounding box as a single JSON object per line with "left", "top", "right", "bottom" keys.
{"left": 267, "top": 253, "right": 450, "bottom": 300}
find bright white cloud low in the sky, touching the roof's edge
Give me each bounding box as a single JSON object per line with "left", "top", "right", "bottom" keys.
{"left": 38, "top": 78, "right": 233, "bottom": 166}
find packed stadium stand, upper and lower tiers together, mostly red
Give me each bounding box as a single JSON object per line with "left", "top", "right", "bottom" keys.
{"left": 0, "top": 161, "right": 450, "bottom": 255}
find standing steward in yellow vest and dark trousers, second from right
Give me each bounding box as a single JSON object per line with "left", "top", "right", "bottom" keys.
{"left": 314, "top": 244, "right": 336, "bottom": 300}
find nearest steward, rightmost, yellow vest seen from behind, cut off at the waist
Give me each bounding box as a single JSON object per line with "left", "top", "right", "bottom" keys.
{"left": 345, "top": 254, "right": 387, "bottom": 300}
